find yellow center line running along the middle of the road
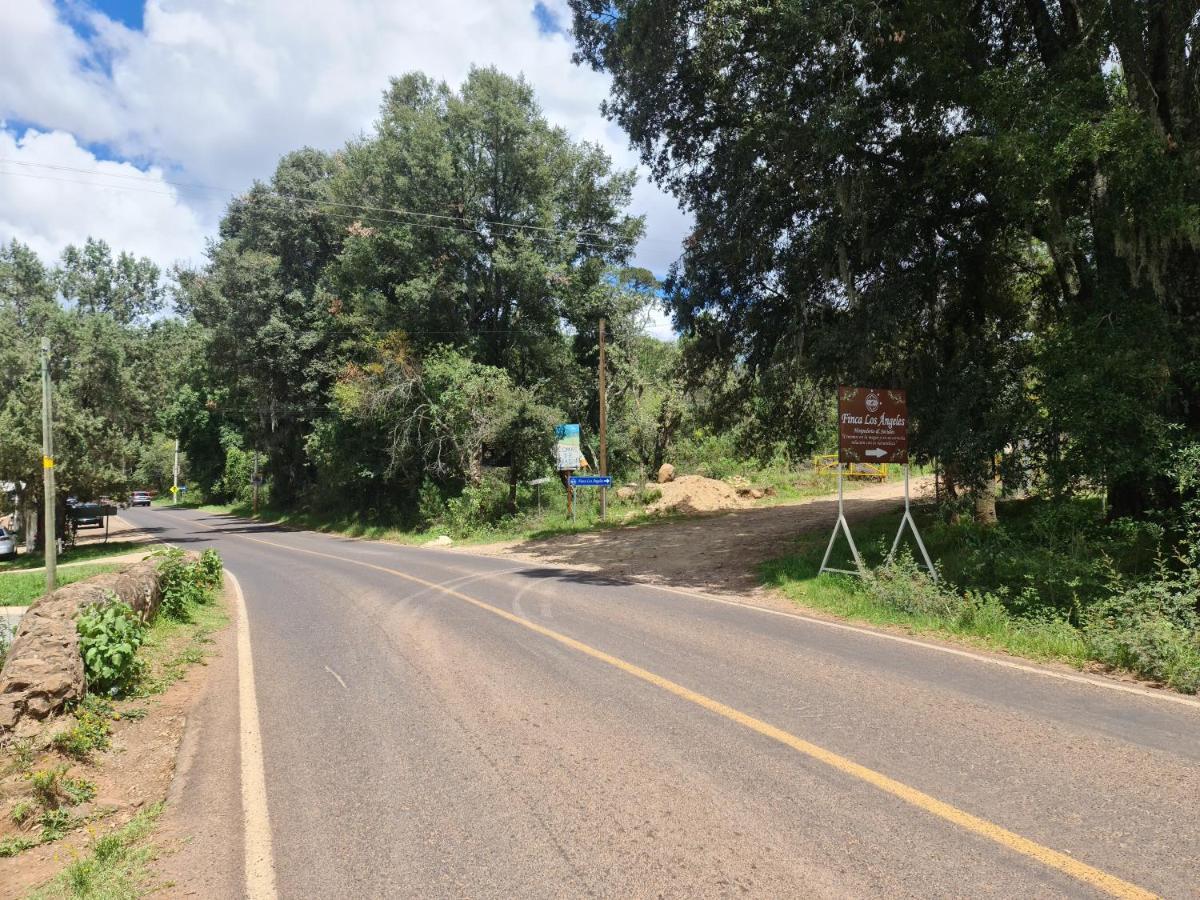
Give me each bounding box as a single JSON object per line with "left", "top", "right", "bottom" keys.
{"left": 182, "top": 513, "right": 1157, "bottom": 899}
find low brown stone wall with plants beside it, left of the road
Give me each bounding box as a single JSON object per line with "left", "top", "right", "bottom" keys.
{"left": 0, "top": 559, "right": 162, "bottom": 742}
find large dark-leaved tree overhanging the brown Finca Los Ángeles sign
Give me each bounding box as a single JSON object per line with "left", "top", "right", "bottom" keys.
{"left": 571, "top": 0, "right": 1200, "bottom": 511}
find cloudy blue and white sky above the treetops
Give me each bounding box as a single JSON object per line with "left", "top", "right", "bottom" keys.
{"left": 0, "top": 0, "right": 690, "bottom": 336}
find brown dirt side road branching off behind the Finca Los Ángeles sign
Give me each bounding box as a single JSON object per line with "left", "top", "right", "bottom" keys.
{"left": 461, "top": 475, "right": 934, "bottom": 594}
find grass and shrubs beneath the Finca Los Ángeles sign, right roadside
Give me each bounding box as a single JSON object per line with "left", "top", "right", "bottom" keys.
{"left": 762, "top": 497, "right": 1200, "bottom": 694}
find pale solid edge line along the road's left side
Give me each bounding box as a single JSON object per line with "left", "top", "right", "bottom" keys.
{"left": 226, "top": 569, "right": 277, "bottom": 900}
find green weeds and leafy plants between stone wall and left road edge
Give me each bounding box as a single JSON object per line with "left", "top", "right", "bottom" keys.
{"left": 0, "top": 548, "right": 227, "bottom": 896}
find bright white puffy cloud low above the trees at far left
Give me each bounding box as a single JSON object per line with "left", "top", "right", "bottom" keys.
{"left": 0, "top": 130, "right": 205, "bottom": 268}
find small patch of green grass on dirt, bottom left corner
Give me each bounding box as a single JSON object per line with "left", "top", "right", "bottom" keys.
{"left": 31, "top": 803, "right": 163, "bottom": 900}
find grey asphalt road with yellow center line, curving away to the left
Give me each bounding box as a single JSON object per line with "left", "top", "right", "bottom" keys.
{"left": 127, "top": 510, "right": 1200, "bottom": 898}
